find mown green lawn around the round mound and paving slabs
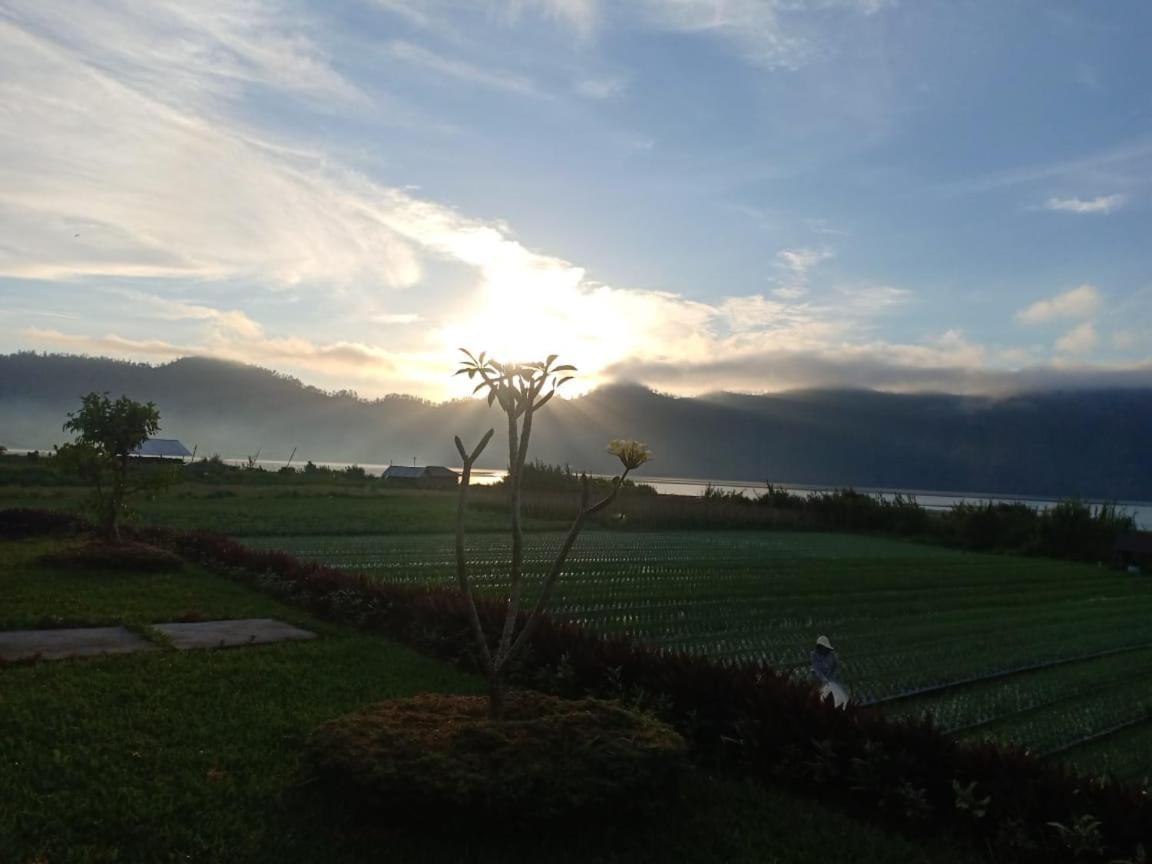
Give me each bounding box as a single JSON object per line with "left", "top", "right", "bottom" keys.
{"left": 0, "top": 541, "right": 976, "bottom": 864}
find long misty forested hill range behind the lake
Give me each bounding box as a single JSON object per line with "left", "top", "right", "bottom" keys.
{"left": 0, "top": 354, "right": 1152, "bottom": 500}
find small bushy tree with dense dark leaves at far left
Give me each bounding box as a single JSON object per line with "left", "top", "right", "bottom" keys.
{"left": 56, "top": 393, "right": 160, "bottom": 543}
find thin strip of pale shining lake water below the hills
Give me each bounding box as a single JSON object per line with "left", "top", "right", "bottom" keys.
{"left": 225, "top": 460, "right": 1152, "bottom": 530}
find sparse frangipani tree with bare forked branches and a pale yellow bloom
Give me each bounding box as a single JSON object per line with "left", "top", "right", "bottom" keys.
{"left": 455, "top": 348, "right": 651, "bottom": 720}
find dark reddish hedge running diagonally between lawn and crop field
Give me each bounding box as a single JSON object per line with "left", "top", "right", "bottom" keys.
{"left": 0, "top": 513, "right": 1152, "bottom": 862}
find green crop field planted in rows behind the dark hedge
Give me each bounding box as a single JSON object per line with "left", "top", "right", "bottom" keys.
{"left": 248, "top": 531, "right": 1152, "bottom": 779}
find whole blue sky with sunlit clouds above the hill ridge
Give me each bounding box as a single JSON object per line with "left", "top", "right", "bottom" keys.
{"left": 0, "top": 0, "right": 1152, "bottom": 400}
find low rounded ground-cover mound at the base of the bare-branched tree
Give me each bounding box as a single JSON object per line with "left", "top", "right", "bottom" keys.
{"left": 304, "top": 691, "right": 684, "bottom": 823}
